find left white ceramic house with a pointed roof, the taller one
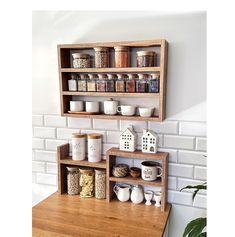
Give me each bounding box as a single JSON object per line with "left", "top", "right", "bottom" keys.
{"left": 120, "top": 125, "right": 137, "bottom": 151}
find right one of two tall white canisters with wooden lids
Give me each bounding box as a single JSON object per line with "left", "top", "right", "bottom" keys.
{"left": 87, "top": 133, "right": 102, "bottom": 162}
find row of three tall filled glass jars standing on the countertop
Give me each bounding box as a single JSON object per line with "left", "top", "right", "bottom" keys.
{"left": 66, "top": 167, "right": 106, "bottom": 199}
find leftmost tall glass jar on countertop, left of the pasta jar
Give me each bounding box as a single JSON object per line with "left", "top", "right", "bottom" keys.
{"left": 66, "top": 167, "right": 80, "bottom": 195}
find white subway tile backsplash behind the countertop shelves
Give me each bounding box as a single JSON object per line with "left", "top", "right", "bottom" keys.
{"left": 32, "top": 114, "right": 207, "bottom": 208}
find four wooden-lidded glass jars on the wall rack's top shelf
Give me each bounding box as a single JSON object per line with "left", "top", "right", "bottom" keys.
{"left": 72, "top": 46, "right": 156, "bottom": 68}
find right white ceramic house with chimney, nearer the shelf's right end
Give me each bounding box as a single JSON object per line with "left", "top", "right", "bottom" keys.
{"left": 141, "top": 130, "right": 158, "bottom": 153}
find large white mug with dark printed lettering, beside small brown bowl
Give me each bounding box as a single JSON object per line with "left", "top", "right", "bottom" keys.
{"left": 141, "top": 161, "right": 162, "bottom": 181}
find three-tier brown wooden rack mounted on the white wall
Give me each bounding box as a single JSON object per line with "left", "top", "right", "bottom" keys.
{"left": 58, "top": 39, "right": 168, "bottom": 121}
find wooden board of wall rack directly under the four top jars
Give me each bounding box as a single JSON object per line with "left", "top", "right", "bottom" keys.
{"left": 60, "top": 67, "right": 160, "bottom": 73}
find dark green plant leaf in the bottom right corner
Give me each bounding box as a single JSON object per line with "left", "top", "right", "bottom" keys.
{"left": 183, "top": 217, "right": 206, "bottom": 237}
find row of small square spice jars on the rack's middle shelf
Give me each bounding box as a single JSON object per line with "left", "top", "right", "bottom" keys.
{"left": 68, "top": 73, "right": 160, "bottom": 93}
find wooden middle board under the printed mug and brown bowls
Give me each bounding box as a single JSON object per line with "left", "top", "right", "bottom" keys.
{"left": 109, "top": 175, "right": 162, "bottom": 187}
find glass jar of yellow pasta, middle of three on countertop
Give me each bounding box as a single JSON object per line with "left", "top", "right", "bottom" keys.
{"left": 79, "top": 168, "right": 94, "bottom": 197}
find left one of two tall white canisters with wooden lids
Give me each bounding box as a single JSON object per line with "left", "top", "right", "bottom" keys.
{"left": 72, "top": 133, "right": 86, "bottom": 160}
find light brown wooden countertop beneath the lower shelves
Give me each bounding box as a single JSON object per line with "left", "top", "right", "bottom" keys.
{"left": 32, "top": 192, "right": 171, "bottom": 237}
